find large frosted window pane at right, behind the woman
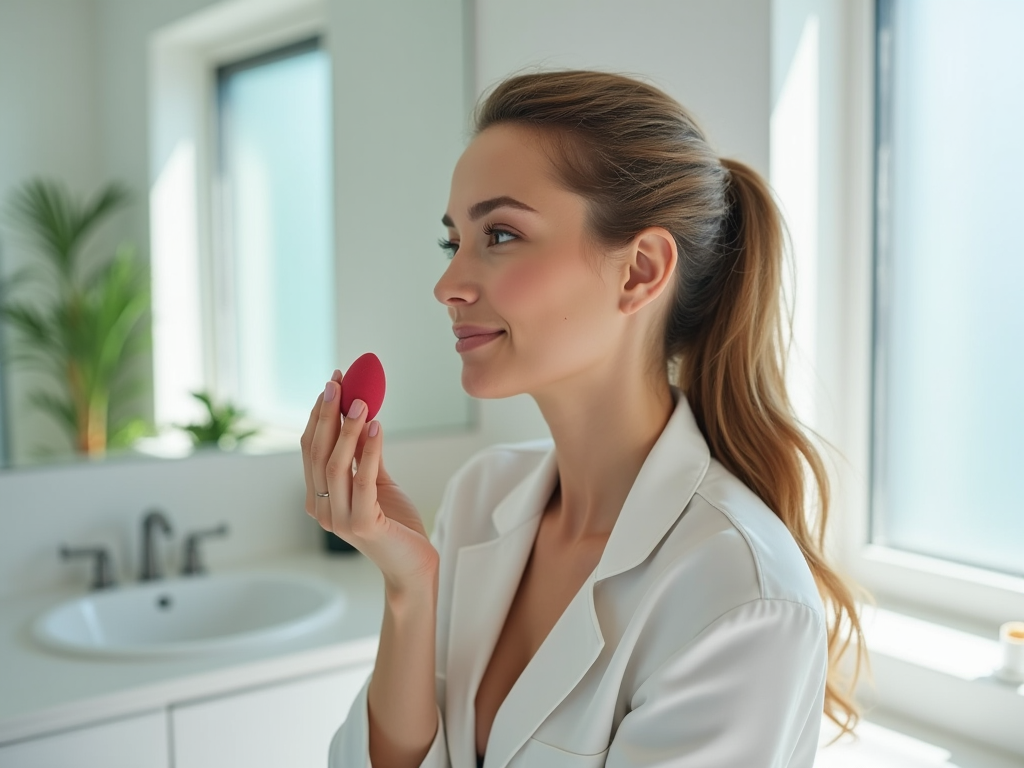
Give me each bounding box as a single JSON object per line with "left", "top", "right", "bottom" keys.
{"left": 870, "top": 0, "right": 1024, "bottom": 577}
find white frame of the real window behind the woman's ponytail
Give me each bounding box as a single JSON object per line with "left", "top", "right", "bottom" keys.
{"left": 835, "top": 0, "right": 1024, "bottom": 634}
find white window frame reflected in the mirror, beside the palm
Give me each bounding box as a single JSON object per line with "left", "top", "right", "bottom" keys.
{"left": 148, "top": 0, "right": 330, "bottom": 444}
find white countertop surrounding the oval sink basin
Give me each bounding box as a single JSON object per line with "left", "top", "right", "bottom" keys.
{"left": 0, "top": 552, "right": 384, "bottom": 744}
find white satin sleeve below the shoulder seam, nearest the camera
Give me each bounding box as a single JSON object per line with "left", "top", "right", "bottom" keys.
{"left": 605, "top": 599, "right": 827, "bottom": 768}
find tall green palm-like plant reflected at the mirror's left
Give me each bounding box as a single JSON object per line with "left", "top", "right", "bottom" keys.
{"left": 0, "top": 178, "right": 153, "bottom": 457}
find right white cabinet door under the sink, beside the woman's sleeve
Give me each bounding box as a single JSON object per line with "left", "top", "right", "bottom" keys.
{"left": 171, "top": 664, "right": 373, "bottom": 768}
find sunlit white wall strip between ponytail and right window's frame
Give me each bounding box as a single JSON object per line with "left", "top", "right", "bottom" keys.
{"left": 770, "top": 0, "right": 860, "bottom": 468}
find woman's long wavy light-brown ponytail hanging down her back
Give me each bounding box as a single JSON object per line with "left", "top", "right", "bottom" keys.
{"left": 677, "top": 160, "right": 866, "bottom": 735}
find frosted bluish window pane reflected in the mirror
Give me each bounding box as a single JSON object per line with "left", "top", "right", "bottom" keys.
{"left": 212, "top": 39, "right": 335, "bottom": 425}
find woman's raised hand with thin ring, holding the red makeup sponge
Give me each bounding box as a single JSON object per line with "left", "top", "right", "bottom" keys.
{"left": 301, "top": 371, "right": 437, "bottom": 592}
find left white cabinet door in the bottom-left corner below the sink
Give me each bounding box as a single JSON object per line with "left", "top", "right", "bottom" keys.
{"left": 0, "top": 710, "right": 170, "bottom": 768}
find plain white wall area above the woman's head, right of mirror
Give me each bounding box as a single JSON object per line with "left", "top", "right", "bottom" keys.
{"left": 475, "top": 0, "right": 770, "bottom": 173}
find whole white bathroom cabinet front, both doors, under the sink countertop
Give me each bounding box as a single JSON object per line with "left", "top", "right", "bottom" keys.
{"left": 0, "top": 664, "right": 373, "bottom": 768}
